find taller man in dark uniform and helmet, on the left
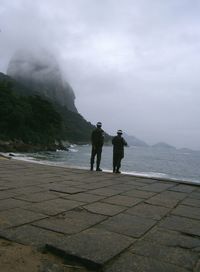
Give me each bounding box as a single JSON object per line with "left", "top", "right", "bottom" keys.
{"left": 90, "top": 122, "right": 104, "bottom": 171}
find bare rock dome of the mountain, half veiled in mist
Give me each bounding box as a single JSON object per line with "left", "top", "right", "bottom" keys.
{"left": 7, "top": 49, "right": 78, "bottom": 112}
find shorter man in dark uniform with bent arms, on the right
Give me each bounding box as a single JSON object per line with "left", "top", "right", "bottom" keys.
{"left": 112, "top": 129, "right": 127, "bottom": 173}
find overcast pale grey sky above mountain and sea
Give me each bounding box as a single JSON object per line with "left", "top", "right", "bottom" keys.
{"left": 0, "top": 0, "right": 200, "bottom": 150}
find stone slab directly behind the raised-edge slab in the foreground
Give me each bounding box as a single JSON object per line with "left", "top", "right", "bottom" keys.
{"left": 98, "top": 214, "right": 156, "bottom": 238}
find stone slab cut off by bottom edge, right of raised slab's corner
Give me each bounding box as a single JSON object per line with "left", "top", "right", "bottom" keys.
{"left": 104, "top": 252, "right": 188, "bottom": 272}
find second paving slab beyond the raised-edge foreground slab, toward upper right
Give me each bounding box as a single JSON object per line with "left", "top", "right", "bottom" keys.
{"left": 126, "top": 203, "right": 170, "bottom": 220}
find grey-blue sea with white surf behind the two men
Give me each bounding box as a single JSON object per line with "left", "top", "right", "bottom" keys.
{"left": 4, "top": 145, "right": 200, "bottom": 185}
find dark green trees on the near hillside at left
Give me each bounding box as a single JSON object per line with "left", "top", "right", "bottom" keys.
{"left": 0, "top": 75, "right": 62, "bottom": 145}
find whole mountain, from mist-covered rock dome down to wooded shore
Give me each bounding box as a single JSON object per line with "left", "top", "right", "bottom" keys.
{"left": 0, "top": 50, "right": 110, "bottom": 151}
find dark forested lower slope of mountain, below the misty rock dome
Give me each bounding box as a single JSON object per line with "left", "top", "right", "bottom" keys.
{"left": 0, "top": 64, "right": 110, "bottom": 152}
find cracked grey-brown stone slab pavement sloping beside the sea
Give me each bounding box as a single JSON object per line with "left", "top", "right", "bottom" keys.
{"left": 0, "top": 159, "right": 200, "bottom": 272}
